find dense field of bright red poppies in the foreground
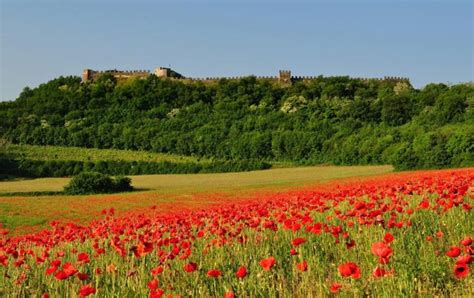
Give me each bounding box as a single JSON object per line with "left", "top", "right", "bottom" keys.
{"left": 0, "top": 168, "right": 474, "bottom": 297}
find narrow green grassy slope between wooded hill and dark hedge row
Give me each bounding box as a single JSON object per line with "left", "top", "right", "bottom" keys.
{"left": 7, "top": 145, "right": 204, "bottom": 163}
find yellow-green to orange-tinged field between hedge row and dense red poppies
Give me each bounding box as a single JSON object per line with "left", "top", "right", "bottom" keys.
{"left": 0, "top": 166, "right": 392, "bottom": 233}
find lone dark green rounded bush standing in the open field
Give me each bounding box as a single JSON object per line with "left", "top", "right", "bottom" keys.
{"left": 64, "top": 172, "right": 133, "bottom": 195}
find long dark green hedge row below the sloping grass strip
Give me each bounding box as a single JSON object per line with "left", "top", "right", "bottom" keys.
{"left": 0, "top": 159, "right": 271, "bottom": 177}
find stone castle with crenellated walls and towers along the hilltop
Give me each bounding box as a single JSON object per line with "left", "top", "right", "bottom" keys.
{"left": 82, "top": 67, "right": 409, "bottom": 86}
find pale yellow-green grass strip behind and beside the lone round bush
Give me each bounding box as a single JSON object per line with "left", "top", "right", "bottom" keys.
{"left": 0, "top": 166, "right": 393, "bottom": 196}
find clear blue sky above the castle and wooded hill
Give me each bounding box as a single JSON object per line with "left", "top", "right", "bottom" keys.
{"left": 0, "top": 0, "right": 474, "bottom": 100}
